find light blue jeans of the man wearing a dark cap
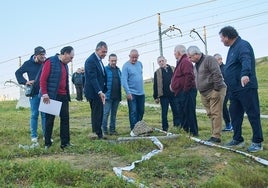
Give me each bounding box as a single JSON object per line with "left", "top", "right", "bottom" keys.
{"left": 29, "top": 95, "right": 46, "bottom": 138}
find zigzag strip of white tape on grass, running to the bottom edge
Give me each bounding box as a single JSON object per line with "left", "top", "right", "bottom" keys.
{"left": 113, "top": 136, "right": 163, "bottom": 187}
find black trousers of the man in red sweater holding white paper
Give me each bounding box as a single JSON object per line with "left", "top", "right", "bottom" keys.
{"left": 45, "top": 95, "right": 70, "bottom": 146}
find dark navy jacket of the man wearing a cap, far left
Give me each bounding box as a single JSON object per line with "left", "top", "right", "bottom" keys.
{"left": 15, "top": 55, "right": 42, "bottom": 95}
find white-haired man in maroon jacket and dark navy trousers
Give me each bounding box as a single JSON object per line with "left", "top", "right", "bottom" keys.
{"left": 170, "top": 45, "right": 198, "bottom": 136}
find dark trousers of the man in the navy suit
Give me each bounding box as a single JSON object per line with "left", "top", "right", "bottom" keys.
{"left": 89, "top": 97, "right": 103, "bottom": 138}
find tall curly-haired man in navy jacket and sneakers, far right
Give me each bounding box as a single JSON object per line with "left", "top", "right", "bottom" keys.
{"left": 219, "top": 26, "right": 263, "bottom": 152}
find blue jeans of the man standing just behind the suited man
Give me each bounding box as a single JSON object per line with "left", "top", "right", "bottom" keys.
{"left": 102, "top": 99, "right": 120, "bottom": 133}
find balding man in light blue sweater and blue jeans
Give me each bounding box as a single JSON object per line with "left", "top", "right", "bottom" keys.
{"left": 121, "top": 49, "right": 145, "bottom": 130}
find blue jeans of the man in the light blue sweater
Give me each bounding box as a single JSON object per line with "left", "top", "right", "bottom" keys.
{"left": 127, "top": 94, "right": 145, "bottom": 130}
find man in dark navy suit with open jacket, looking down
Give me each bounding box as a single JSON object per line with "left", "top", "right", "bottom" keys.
{"left": 84, "top": 41, "right": 108, "bottom": 139}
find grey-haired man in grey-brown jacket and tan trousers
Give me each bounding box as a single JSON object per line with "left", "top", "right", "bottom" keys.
{"left": 187, "top": 46, "right": 226, "bottom": 143}
